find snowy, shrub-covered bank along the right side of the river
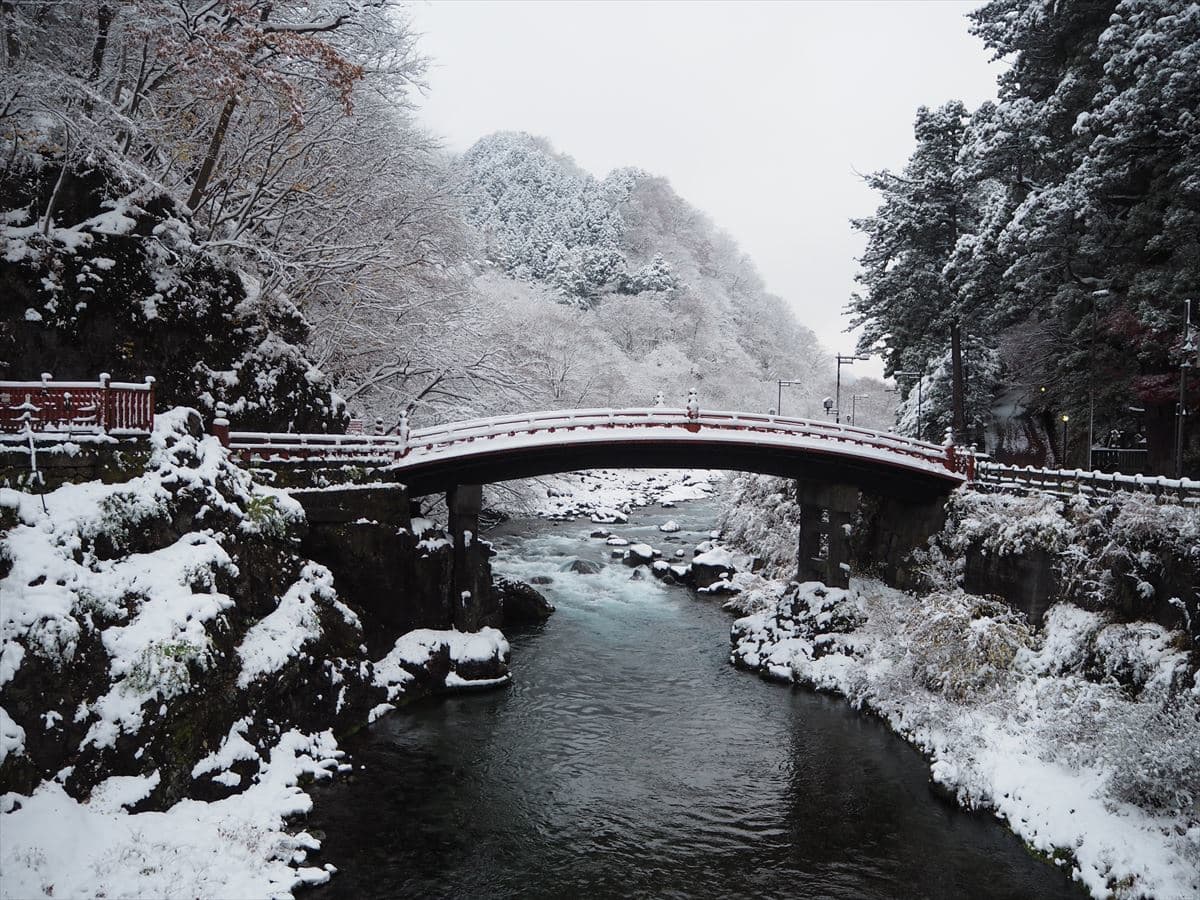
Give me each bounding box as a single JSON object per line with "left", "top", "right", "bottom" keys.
{"left": 724, "top": 479, "right": 1200, "bottom": 898}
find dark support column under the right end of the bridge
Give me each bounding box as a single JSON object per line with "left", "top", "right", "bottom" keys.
{"left": 796, "top": 479, "right": 858, "bottom": 588}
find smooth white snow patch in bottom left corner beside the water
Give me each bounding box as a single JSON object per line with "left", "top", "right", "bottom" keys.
{"left": 0, "top": 731, "right": 342, "bottom": 900}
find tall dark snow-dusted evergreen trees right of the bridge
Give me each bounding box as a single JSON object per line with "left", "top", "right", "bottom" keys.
{"left": 851, "top": 0, "right": 1200, "bottom": 470}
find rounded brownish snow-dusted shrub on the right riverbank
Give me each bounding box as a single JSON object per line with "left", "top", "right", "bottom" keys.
{"left": 910, "top": 592, "right": 1032, "bottom": 700}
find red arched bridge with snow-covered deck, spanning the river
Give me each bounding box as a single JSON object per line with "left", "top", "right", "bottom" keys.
{"left": 217, "top": 407, "right": 974, "bottom": 499}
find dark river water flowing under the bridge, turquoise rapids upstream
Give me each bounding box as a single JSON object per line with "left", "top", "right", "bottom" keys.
{"left": 306, "top": 502, "right": 1081, "bottom": 900}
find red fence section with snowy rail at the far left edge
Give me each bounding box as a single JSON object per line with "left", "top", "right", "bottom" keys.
{"left": 0, "top": 372, "right": 154, "bottom": 434}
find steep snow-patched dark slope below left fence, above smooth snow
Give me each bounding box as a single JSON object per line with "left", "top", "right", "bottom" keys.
{"left": 0, "top": 409, "right": 373, "bottom": 808}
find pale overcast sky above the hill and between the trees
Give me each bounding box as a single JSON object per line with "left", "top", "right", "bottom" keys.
{"left": 412, "top": 0, "right": 1000, "bottom": 374}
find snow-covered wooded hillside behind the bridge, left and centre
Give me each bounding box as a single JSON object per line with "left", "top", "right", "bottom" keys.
{"left": 0, "top": 0, "right": 828, "bottom": 430}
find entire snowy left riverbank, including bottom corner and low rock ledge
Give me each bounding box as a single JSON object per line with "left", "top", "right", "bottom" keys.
{"left": 0, "top": 410, "right": 508, "bottom": 900}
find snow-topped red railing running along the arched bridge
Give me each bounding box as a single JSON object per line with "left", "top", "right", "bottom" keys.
{"left": 228, "top": 407, "right": 974, "bottom": 478}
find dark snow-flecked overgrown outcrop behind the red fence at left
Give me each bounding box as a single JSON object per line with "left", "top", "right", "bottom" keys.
{"left": 0, "top": 170, "right": 346, "bottom": 431}
